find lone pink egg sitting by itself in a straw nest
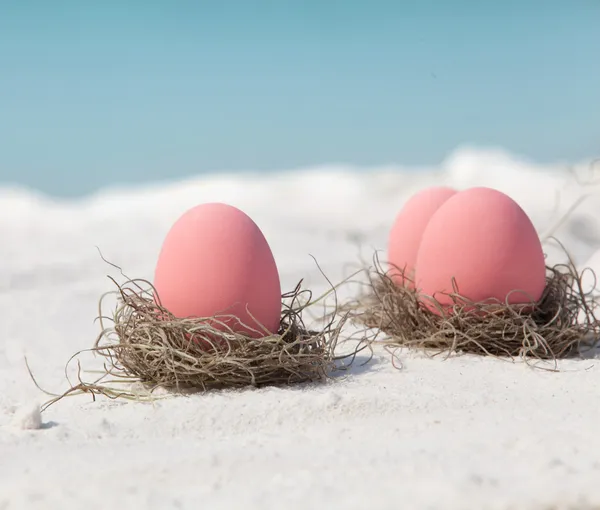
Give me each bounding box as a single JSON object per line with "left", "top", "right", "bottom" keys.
{"left": 154, "top": 203, "right": 281, "bottom": 337}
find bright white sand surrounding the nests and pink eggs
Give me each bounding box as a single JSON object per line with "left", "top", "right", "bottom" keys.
{"left": 0, "top": 145, "right": 600, "bottom": 510}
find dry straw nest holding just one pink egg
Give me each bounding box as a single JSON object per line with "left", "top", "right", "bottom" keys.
{"left": 37, "top": 270, "right": 370, "bottom": 409}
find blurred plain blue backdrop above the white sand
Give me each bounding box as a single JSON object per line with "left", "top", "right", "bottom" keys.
{"left": 0, "top": 0, "right": 600, "bottom": 196}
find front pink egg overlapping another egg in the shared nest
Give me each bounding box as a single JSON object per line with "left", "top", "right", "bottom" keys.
{"left": 415, "top": 188, "right": 546, "bottom": 305}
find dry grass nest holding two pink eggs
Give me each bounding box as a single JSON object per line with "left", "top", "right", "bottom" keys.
{"left": 341, "top": 253, "right": 600, "bottom": 361}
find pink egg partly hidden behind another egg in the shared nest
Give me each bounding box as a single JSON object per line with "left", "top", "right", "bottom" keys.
{"left": 388, "top": 186, "right": 456, "bottom": 287}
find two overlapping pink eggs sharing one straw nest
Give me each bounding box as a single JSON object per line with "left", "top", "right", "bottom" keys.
{"left": 388, "top": 187, "right": 546, "bottom": 311}
